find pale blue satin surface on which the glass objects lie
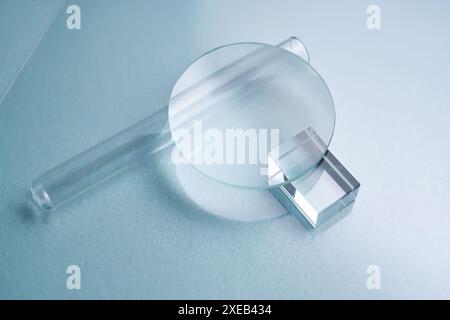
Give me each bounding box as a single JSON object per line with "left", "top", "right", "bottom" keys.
{"left": 0, "top": 0, "right": 450, "bottom": 299}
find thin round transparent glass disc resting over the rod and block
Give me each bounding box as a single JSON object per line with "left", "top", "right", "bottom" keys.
{"left": 169, "top": 43, "right": 335, "bottom": 188}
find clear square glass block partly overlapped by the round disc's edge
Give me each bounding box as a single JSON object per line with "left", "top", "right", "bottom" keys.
{"left": 271, "top": 128, "right": 360, "bottom": 228}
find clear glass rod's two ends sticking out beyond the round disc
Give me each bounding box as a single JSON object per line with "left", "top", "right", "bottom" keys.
{"left": 31, "top": 37, "right": 309, "bottom": 209}
